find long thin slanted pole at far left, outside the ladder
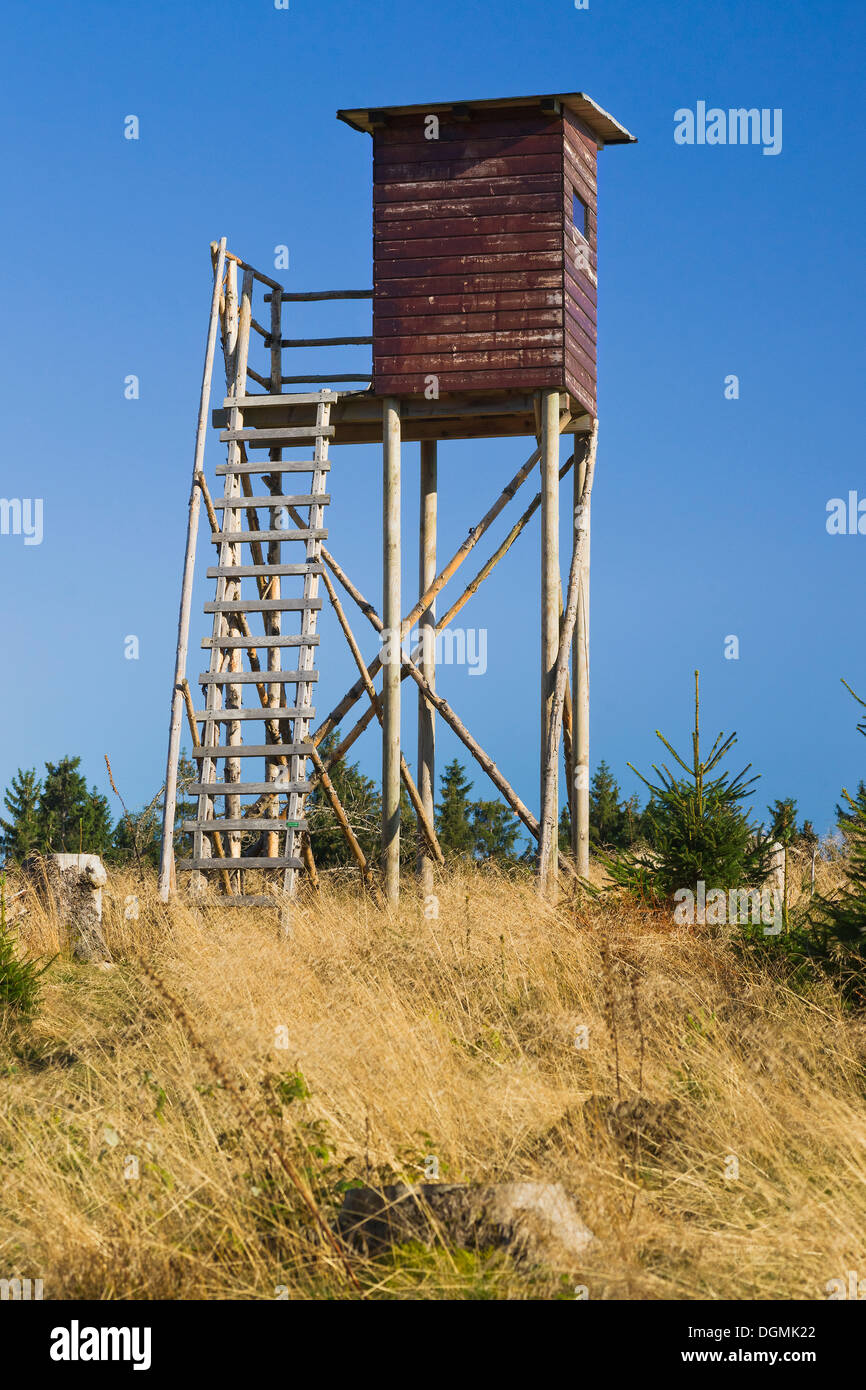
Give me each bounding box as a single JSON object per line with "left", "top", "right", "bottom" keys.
{"left": 160, "top": 236, "right": 225, "bottom": 902}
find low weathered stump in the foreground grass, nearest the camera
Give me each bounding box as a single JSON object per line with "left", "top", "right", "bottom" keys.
{"left": 336, "top": 1182, "right": 595, "bottom": 1272}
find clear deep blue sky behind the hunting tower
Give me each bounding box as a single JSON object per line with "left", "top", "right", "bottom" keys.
{"left": 0, "top": 0, "right": 866, "bottom": 830}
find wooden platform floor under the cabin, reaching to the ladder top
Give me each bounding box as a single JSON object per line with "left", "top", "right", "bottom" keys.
{"left": 211, "top": 389, "right": 592, "bottom": 447}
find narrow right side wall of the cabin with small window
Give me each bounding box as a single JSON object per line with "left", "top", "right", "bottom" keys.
{"left": 563, "top": 111, "right": 598, "bottom": 416}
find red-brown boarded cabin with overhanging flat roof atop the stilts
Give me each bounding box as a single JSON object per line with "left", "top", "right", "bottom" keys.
{"left": 338, "top": 92, "right": 634, "bottom": 414}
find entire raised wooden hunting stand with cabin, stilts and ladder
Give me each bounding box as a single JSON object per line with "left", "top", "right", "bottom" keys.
{"left": 160, "top": 92, "right": 634, "bottom": 922}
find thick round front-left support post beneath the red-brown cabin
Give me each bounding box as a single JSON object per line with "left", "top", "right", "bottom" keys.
{"left": 382, "top": 396, "right": 402, "bottom": 906}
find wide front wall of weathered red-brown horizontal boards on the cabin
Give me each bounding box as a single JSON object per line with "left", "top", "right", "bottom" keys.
{"left": 373, "top": 110, "right": 569, "bottom": 396}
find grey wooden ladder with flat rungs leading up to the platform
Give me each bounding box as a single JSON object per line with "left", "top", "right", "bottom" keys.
{"left": 177, "top": 389, "right": 338, "bottom": 905}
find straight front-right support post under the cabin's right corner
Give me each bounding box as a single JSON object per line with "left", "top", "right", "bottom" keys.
{"left": 539, "top": 391, "right": 562, "bottom": 887}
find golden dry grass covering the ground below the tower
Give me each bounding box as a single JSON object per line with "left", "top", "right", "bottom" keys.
{"left": 0, "top": 872, "right": 866, "bottom": 1300}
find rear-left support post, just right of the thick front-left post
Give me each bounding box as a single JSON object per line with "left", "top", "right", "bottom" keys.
{"left": 418, "top": 439, "right": 438, "bottom": 897}
